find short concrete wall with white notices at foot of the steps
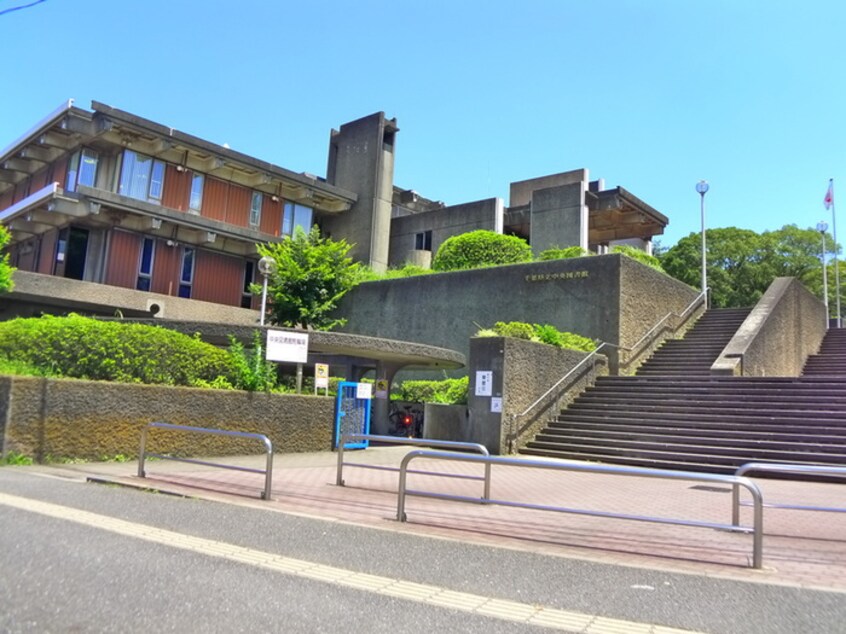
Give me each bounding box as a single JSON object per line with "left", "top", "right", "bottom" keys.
{"left": 463, "top": 337, "right": 608, "bottom": 454}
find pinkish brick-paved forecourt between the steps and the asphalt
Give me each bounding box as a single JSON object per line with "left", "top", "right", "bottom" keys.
{"left": 33, "top": 447, "right": 846, "bottom": 592}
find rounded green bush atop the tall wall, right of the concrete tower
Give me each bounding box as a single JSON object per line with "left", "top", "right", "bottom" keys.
{"left": 432, "top": 229, "right": 532, "bottom": 271}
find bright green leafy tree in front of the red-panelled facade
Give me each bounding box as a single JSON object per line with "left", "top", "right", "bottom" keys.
{"left": 253, "top": 226, "right": 361, "bottom": 330}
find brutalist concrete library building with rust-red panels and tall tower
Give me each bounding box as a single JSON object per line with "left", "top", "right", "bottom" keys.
{"left": 0, "top": 100, "right": 667, "bottom": 323}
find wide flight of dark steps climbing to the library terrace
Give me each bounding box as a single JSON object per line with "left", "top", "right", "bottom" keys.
{"left": 521, "top": 310, "right": 846, "bottom": 473}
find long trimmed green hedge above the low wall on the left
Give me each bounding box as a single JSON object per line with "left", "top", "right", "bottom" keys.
{"left": 0, "top": 315, "right": 234, "bottom": 385}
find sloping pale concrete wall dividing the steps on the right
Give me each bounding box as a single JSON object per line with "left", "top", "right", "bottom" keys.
{"left": 711, "top": 277, "right": 826, "bottom": 376}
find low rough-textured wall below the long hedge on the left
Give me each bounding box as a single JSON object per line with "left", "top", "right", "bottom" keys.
{"left": 0, "top": 376, "right": 334, "bottom": 461}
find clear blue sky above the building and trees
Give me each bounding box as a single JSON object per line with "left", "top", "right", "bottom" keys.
{"left": 0, "top": 0, "right": 846, "bottom": 246}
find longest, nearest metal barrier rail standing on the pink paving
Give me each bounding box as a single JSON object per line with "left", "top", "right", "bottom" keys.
{"left": 397, "top": 449, "right": 764, "bottom": 569}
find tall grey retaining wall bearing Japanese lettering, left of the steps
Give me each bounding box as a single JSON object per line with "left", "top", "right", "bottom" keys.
{"left": 339, "top": 254, "right": 697, "bottom": 376}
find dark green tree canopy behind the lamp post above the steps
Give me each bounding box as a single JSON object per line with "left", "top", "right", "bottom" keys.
{"left": 659, "top": 225, "right": 839, "bottom": 308}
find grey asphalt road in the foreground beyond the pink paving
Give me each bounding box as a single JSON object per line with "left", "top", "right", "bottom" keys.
{"left": 0, "top": 467, "right": 846, "bottom": 634}
